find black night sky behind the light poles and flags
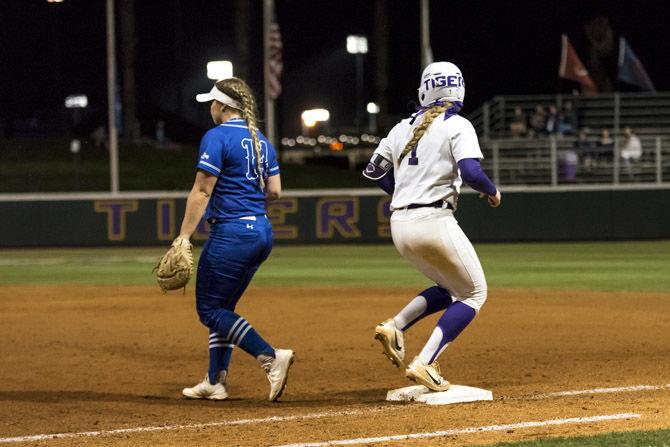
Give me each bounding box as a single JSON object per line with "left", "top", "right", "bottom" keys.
{"left": 0, "top": 0, "right": 670, "bottom": 140}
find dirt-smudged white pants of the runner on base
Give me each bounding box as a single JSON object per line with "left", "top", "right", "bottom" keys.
{"left": 391, "top": 208, "right": 487, "bottom": 312}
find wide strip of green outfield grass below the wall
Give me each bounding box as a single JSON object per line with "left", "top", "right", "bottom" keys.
{"left": 0, "top": 241, "right": 670, "bottom": 292}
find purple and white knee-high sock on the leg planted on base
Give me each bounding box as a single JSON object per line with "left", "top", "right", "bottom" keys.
{"left": 419, "top": 301, "right": 477, "bottom": 365}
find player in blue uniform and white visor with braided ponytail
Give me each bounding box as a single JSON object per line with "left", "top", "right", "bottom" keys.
{"left": 179, "top": 78, "right": 293, "bottom": 401}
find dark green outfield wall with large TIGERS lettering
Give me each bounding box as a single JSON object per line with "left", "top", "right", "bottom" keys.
{"left": 0, "top": 187, "right": 670, "bottom": 247}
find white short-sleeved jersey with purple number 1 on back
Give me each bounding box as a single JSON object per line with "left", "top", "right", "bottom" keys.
{"left": 375, "top": 114, "right": 484, "bottom": 210}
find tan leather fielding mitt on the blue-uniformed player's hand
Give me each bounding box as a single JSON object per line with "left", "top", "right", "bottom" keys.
{"left": 153, "top": 237, "right": 193, "bottom": 293}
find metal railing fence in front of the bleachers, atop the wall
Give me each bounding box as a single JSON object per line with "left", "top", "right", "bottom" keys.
{"left": 481, "top": 136, "right": 670, "bottom": 186}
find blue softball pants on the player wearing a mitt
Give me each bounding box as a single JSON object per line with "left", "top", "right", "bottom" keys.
{"left": 195, "top": 216, "right": 274, "bottom": 332}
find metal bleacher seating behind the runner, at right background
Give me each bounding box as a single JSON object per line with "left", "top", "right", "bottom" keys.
{"left": 468, "top": 92, "right": 670, "bottom": 186}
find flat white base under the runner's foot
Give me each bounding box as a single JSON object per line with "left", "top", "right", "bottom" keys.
{"left": 386, "top": 385, "right": 493, "bottom": 405}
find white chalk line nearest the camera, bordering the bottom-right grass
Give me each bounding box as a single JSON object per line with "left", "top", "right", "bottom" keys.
{"left": 274, "top": 413, "right": 641, "bottom": 447}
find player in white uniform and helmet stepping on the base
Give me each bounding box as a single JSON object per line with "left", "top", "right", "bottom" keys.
{"left": 363, "top": 62, "right": 500, "bottom": 391}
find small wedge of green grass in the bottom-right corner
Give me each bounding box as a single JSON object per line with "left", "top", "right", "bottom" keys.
{"left": 486, "top": 430, "right": 670, "bottom": 447}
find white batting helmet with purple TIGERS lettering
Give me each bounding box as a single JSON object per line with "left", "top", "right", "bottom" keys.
{"left": 418, "top": 62, "right": 465, "bottom": 107}
